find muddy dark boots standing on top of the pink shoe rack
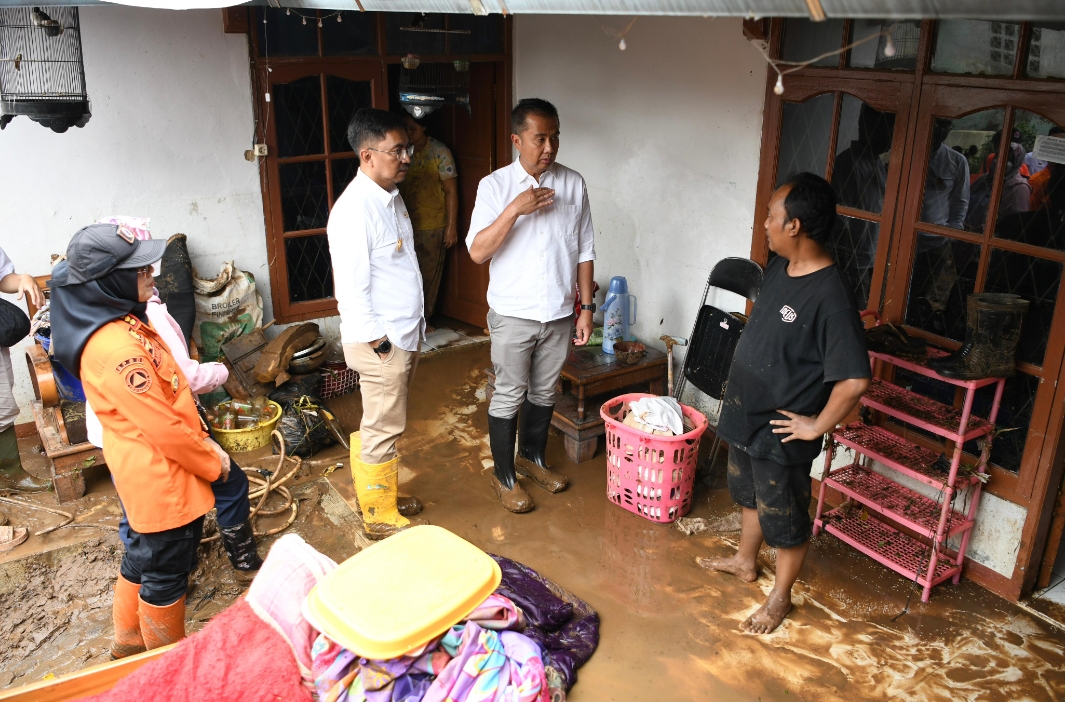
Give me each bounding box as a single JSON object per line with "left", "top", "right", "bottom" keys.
{"left": 928, "top": 293, "right": 1029, "bottom": 380}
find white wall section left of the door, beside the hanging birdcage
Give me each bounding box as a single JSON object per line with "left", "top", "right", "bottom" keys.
{"left": 0, "top": 6, "right": 266, "bottom": 422}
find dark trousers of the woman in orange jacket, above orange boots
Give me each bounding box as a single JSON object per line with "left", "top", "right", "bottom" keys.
{"left": 120, "top": 517, "right": 203, "bottom": 607}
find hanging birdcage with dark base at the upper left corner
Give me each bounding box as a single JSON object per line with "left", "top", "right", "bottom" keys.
{"left": 0, "top": 6, "right": 91, "bottom": 132}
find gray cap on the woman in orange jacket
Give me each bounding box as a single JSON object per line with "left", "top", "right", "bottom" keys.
{"left": 58, "top": 224, "right": 166, "bottom": 284}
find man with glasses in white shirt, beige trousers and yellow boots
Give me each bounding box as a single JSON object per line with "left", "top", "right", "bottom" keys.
{"left": 326, "top": 109, "right": 425, "bottom": 539}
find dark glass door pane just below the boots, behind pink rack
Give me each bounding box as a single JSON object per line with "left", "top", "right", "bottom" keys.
{"left": 965, "top": 370, "right": 1039, "bottom": 473}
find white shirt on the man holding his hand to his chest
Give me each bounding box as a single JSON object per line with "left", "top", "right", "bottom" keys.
{"left": 466, "top": 161, "right": 595, "bottom": 323}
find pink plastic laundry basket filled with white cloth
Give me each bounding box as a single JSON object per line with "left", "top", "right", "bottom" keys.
{"left": 600, "top": 392, "right": 707, "bottom": 523}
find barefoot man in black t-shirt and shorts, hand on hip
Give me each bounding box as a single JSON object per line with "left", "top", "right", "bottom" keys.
{"left": 699, "top": 173, "right": 870, "bottom": 634}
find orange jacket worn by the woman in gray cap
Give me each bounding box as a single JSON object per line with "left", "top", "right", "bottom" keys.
{"left": 81, "top": 315, "right": 222, "bottom": 534}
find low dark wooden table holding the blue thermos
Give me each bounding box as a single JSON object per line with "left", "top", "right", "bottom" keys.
{"left": 485, "top": 346, "right": 668, "bottom": 463}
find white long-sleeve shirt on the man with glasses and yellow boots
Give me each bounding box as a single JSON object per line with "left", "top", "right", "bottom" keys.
{"left": 326, "top": 169, "right": 425, "bottom": 352}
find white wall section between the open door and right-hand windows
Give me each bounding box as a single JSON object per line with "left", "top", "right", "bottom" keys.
{"left": 514, "top": 15, "right": 766, "bottom": 345}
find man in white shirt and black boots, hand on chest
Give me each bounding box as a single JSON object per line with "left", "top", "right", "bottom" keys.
{"left": 466, "top": 98, "right": 595, "bottom": 512}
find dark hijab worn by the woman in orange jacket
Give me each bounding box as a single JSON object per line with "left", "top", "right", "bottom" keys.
{"left": 49, "top": 261, "right": 148, "bottom": 380}
